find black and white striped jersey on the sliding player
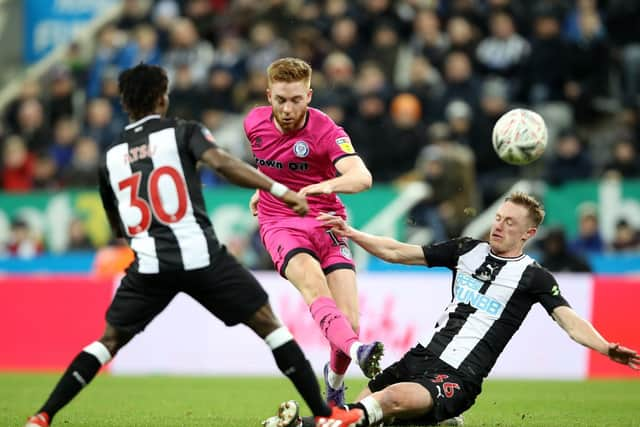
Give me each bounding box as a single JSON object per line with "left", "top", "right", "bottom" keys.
{"left": 421, "top": 238, "right": 569, "bottom": 384}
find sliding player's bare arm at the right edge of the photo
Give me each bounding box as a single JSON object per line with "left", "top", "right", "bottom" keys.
{"left": 552, "top": 306, "right": 640, "bottom": 370}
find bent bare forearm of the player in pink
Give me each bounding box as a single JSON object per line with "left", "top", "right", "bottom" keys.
{"left": 298, "top": 156, "right": 373, "bottom": 196}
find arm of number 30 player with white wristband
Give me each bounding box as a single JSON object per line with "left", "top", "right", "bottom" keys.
{"left": 201, "top": 147, "right": 309, "bottom": 216}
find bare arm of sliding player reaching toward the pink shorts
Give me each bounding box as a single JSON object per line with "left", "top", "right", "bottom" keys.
{"left": 318, "top": 214, "right": 426, "bottom": 265}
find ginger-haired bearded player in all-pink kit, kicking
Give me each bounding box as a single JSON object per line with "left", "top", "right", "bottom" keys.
{"left": 244, "top": 58, "right": 383, "bottom": 405}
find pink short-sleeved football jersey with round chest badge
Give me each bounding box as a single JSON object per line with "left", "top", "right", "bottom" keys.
{"left": 244, "top": 106, "right": 356, "bottom": 223}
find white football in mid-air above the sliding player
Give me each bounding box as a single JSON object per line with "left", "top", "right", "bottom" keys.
{"left": 491, "top": 108, "right": 547, "bottom": 165}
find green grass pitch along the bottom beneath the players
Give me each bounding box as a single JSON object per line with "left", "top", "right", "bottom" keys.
{"left": 0, "top": 374, "right": 640, "bottom": 427}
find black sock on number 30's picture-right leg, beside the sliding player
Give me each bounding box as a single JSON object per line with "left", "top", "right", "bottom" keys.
{"left": 272, "top": 340, "right": 331, "bottom": 416}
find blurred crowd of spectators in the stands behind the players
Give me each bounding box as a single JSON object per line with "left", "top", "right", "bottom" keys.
{"left": 0, "top": 0, "right": 640, "bottom": 262}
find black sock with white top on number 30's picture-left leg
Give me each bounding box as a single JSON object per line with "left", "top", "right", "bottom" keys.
{"left": 38, "top": 343, "right": 110, "bottom": 420}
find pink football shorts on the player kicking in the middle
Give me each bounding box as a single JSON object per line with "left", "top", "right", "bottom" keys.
{"left": 260, "top": 218, "right": 355, "bottom": 277}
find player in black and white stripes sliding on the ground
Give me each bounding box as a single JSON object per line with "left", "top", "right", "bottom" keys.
{"left": 264, "top": 193, "right": 640, "bottom": 427}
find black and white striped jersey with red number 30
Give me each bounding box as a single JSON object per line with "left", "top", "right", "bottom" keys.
{"left": 99, "top": 115, "right": 220, "bottom": 273}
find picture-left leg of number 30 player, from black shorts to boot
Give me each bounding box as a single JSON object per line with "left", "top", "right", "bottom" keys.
{"left": 26, "top": 273, "right": 175, "bottom": 427}
